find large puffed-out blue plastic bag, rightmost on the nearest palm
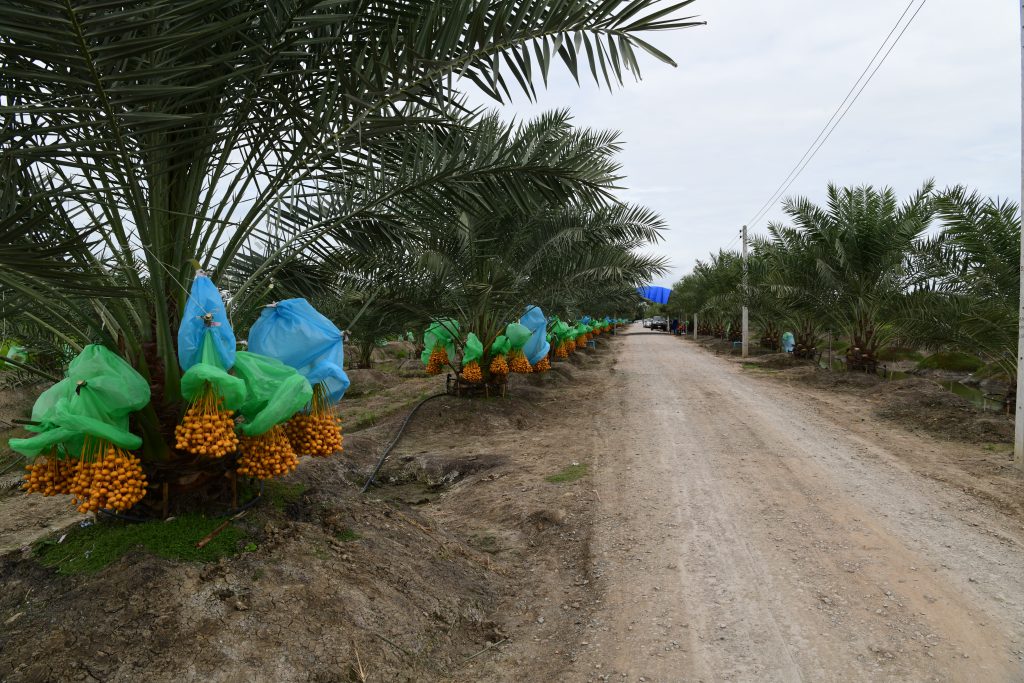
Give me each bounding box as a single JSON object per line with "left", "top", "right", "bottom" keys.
{"left": 249, "top": 299, "right": 351, "bottom": 403}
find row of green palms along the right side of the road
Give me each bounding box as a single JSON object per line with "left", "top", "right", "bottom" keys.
{"left": 670, "top": 182, "right": 1020, "bottom": 377}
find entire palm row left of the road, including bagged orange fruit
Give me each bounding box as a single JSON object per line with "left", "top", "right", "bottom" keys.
{"left": 0, "top": 0, "right": 695, "bottom": 515}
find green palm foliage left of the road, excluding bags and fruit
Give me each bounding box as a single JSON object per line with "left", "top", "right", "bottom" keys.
{"left": 0, "top": 0, "right": 698, "bottom": 458}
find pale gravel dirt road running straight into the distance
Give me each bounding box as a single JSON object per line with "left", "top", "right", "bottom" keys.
{"left": 567, "top": 331, "right": 1024, "bottom": 682}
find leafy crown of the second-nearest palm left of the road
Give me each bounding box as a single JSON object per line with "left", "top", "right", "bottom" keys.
{"left": 319, "top": 112, "right": 665, "bottom": 358}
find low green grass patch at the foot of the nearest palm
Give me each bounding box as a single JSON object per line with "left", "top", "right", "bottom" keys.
{"left": 35, "top": 514, "right": 246, "bottom": 574}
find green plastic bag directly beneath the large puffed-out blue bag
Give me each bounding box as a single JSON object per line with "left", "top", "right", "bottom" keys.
{"left": 234, "top": 351, "right": 313, "bottom": 436}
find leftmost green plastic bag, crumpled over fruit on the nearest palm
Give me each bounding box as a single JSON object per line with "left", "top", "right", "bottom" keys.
{"left": 9, "top": 344, "right": 150, "bottom": 457}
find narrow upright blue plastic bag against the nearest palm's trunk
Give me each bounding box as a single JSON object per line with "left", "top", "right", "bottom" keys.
{"left": 178, "top": 272, "right": 234, "bottom": 370}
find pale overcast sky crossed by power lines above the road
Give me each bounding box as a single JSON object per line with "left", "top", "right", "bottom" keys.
{"left": 468, "top": 0, "right": 1021, "bottom": 286}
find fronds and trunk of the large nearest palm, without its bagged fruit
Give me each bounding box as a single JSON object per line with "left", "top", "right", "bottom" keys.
{"left": 0, "top": 0, "right": 697, "bottom": 458}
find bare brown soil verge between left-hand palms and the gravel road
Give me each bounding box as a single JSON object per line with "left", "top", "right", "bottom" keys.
{"left": 0, "top": 344, "right": 611, "bottom": 683}
